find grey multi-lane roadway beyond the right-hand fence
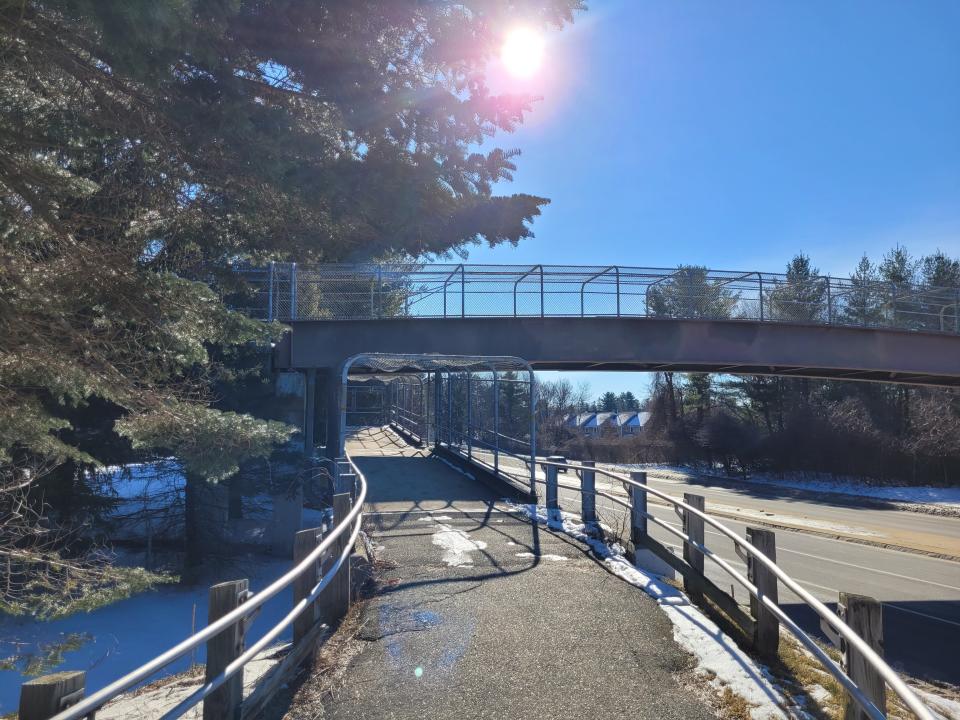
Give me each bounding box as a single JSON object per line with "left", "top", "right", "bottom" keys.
{"left": 466, "top": 448, "right": 960, "bottom": 684}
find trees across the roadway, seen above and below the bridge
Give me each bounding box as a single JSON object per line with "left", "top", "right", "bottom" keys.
{"left": 538, "top": 247, "right": 960, "bottom": 485}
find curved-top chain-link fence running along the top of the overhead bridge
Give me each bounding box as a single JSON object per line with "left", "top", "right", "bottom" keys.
{"left": 234, "top": 263, "right": 960, "bottom": 333}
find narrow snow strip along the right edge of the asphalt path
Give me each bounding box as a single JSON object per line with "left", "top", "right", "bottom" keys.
{"left": 510, "top": 503, "right": 808, "bottom": 720}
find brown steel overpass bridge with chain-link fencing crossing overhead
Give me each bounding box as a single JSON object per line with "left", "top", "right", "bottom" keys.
{"left": 249, "top": 263, "right": 960, "bottom": 386}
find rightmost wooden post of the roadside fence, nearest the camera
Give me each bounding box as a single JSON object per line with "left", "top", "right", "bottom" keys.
{"left": 837, "top": 592, "right": 887, "bottom": 720}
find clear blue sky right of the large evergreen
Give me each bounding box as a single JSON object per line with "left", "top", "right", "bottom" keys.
{"left": 470, "top": 0, "right": 960, "bottom": 400}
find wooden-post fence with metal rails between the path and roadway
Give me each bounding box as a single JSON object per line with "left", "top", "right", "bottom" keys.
{"left": 538, "top": 457, "right": 916, "bottom": 720}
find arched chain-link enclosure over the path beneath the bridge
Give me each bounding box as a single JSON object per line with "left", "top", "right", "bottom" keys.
{"left": 338, "top": 354, "right": 536, "bottom": 492}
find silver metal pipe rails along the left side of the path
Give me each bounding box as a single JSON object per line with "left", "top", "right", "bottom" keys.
{"left": 52, "top": 455, "right": 367, "bottom": 720}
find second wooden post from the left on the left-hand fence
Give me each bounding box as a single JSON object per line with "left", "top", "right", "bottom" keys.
{"left": 203, "top": 580, "right": 250, "bottom": 720}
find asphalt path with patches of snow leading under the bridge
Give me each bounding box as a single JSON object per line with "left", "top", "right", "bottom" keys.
{"left": 325, "top": 431, "right": 714, "bottom": 720}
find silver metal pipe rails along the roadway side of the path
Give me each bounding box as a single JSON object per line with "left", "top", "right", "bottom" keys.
{"left": 536, "top": 460, "right": 935, "bottom": 720}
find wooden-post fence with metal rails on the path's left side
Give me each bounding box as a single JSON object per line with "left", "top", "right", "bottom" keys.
{"left": 19, "top": 460, "right": 366, "bottom": 720}
